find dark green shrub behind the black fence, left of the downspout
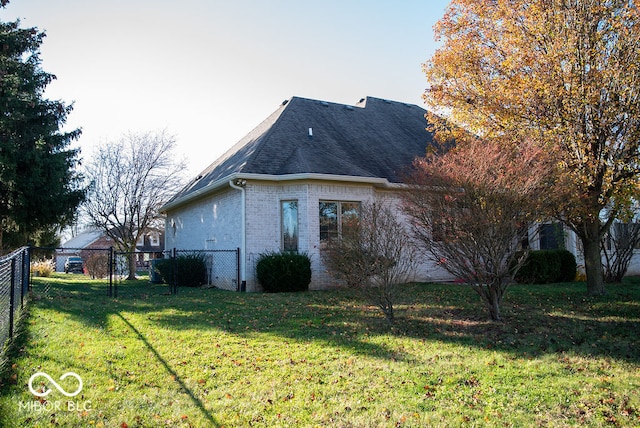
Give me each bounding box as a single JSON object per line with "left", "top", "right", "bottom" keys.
{"left": 154, "top": 252, "right": 207, "bottom": 287}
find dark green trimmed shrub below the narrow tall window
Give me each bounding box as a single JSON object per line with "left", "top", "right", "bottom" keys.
{"left": 256, "top": 252, "right": 311, "bottom": 293}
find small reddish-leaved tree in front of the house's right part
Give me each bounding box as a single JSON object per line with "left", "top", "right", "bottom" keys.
{"left": 404, "top": 140, "right": 552, "bottom": 321}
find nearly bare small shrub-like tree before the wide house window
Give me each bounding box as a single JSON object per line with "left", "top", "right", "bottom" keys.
{"left": 321, "top": 202, "right": 416, "bottom": 323}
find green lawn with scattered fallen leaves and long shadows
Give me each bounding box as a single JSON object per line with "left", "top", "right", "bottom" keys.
{"left": 0, "top": 275, "right": 640, "bottom": 427}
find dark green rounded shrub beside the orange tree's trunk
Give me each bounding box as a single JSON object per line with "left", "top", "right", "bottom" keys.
{"left": 515, "top": 250, "right": 577, "bottom": 284}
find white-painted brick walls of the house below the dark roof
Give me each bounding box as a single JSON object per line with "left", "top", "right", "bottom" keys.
{"left": 166, "top": 180, "right": 451, "bottom": 292}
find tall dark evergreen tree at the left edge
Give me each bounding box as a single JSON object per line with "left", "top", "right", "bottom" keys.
{"left": 0, "top": 1, "right": 85, "bottom": 251}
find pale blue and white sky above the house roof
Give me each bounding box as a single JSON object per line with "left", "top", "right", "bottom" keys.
{"left": 0, "top": 0, "right": 448, "bottom": 175}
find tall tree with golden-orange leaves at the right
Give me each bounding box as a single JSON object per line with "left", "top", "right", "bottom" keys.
{"left": 424, "top": 0, "right": 640, "bottom": 294}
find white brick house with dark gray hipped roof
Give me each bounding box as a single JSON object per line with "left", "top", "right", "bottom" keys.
{"left": 163, "top": 97, "right": 449, "bottom": 291}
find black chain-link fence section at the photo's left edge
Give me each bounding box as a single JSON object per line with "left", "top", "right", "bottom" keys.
{"left": 0, "top": 247, "right": 30, "bottom": 353}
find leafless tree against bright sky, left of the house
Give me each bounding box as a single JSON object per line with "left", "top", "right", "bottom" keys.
{"left": 83, "top": 130, "right": 185, "bottom": 279}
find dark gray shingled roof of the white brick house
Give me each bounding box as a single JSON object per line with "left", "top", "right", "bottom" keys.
{"left": 173, "top": 97, "right": 432, "bottom": 201}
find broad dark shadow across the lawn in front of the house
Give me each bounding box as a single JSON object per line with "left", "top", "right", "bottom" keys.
{"left": 27, "top": 278, "right": 640, "bottom": 363}
